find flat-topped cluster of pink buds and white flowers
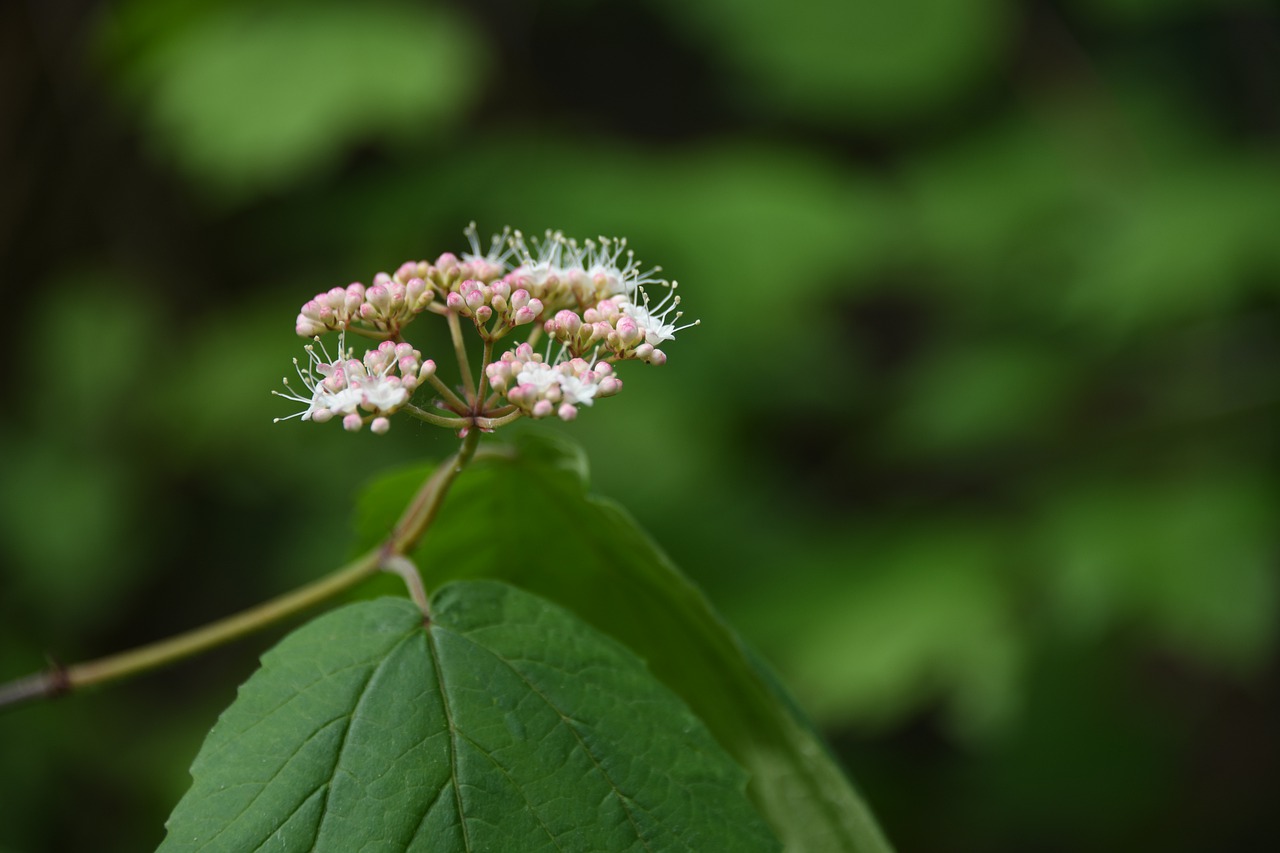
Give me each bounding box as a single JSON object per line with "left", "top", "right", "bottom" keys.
{"left": 273, "top": 223, "right": 696, "bottom": 433}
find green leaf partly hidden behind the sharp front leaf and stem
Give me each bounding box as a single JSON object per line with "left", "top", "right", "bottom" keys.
{"left": 357, "top": 434, "right": 888, "bottom": 852}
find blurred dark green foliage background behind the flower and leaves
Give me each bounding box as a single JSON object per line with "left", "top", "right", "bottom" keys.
{"left": 0, "top": 0, "right": 1280, "bottom": 852}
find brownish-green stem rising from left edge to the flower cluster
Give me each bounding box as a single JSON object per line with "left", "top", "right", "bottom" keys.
{"left": 0, "top": 429, "right": 480, "bottom": 708}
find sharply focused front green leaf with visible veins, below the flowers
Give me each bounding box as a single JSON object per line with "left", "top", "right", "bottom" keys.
{"left": 160, "top": 581, "right": 777, "bottom": 853}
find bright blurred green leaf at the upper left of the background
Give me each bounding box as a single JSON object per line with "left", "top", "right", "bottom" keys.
{"left": 102, "top": 0, "right": 488, "bottom": 199}
